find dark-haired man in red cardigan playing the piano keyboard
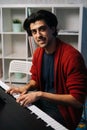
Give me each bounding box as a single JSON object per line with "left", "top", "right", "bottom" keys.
{"left": 7, "top": 10, "right": 87, "bottom": 130}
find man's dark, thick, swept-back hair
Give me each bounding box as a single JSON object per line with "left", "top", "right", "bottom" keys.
{"left": 23, "top": 10, "right": 58, "bottom": 36}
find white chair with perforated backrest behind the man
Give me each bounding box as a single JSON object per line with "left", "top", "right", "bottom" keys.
{"left": 9, "top": 60, "right": 32, "bottom": 84}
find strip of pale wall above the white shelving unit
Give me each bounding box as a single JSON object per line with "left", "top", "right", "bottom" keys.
{"left": 0, "top": 0, "right": 87, "bottom": 7}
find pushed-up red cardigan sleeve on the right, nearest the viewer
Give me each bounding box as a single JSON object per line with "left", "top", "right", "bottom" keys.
{"left": 64, "top": 47, "right": 87, "bottom": 103}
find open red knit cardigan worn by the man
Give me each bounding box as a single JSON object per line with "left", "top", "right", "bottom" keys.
{"left": 31, "top": 39, "right": 87, "bottom": 130}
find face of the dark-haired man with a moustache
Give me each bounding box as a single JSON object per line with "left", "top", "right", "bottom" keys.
{"left": 30, "top": 20, "right": 54, "bottom": 48}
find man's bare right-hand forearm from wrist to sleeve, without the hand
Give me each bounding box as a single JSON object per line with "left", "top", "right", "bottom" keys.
{"left": 38, "top": 92, "right": 82, "bottom": 108}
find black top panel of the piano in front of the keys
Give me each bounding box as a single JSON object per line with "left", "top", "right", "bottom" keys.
{"left": 0, "top": 87, "right": 53, "bottom": 130}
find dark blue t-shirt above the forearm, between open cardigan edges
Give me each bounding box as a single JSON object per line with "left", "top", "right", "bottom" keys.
{"left": 42, "top": 53, "right": 54, "bottom": 93}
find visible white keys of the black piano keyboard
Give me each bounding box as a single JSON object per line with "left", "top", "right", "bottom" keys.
{"left": 0, "top": 80, "right": 68, "bottom": 130}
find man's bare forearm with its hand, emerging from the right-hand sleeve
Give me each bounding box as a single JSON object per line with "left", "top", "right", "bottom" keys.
{"left": 17, "top": 91, "right": 82, "bottom": 108}
